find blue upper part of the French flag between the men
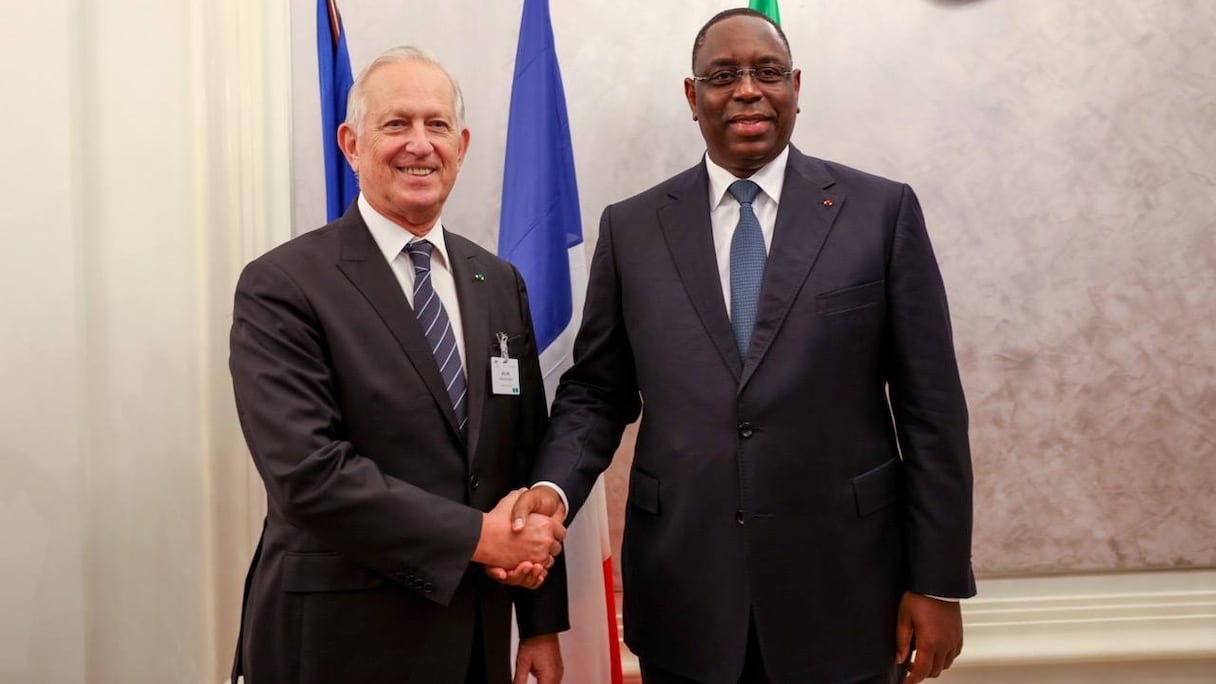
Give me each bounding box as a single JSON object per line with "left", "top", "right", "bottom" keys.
{"left": 499, "top": 0, "right": 582, "bottom": 352}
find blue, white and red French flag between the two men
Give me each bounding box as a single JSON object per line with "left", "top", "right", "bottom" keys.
{"left": 499, "top": 0, "right": 623, "bottom": 684}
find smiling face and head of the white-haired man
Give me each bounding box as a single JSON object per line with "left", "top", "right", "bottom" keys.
{"left": 338, "top": 61, "right": 469, "bottom": 235}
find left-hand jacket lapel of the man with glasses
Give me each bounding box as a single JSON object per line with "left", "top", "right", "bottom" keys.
{"left": 658, "top": 162, "right": 743, "bottom": 380}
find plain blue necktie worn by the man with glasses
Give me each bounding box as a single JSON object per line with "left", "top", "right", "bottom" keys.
{"left": 730, "top": 180, "right": 765, "bottom": 359}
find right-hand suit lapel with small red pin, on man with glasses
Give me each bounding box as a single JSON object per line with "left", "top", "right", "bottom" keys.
{"left": 739, "top": 145, "right": 845, "bottom": 391}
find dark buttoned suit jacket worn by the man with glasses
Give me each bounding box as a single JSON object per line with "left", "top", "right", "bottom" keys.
{"left": 536, "top": 148, "right": 974, "bottom": 684}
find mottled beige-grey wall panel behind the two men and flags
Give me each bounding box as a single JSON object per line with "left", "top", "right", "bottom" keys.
{"left": 293, "top": 0, "right": 1216, "bottom": 576}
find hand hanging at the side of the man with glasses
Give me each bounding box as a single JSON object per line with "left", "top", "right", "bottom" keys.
{"left": 895, "top": 592, "right": 963, "bottom": 684}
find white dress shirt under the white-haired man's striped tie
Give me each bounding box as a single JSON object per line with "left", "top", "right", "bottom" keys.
{"left": 359, "top": 194, "right": 468, "bottom": 376}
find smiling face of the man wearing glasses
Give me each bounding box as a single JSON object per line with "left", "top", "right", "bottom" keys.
{"left": 685, "top": 16, "right": 803, "bottom": 178}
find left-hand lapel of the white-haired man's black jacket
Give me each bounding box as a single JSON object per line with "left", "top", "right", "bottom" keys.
{"left": 338, "top": 204, "right": 463, "bottom": 439}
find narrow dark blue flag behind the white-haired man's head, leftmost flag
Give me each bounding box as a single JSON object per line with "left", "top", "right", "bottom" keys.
{"left": 316, "top": 0, "right": 359, "bottom": 220}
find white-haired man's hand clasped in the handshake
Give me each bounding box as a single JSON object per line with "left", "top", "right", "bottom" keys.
{"left": 473, "top": 489, "right": 565, "bottom": 567}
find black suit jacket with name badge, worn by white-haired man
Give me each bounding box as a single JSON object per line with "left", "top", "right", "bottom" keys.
{"left": 230, "top": 204, "right": 567, "bottom": 684}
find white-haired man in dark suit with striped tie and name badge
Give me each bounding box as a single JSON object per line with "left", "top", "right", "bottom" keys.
{"left": 231, "top": 49, "right": 567, "bottom": 684}
